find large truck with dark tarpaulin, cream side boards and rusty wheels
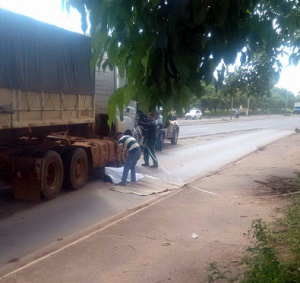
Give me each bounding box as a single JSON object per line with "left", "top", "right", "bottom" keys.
{"left": 0, "top": 9, "right": 133, "bottom": 200}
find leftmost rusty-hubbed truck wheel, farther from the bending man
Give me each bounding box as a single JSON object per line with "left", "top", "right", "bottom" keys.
{"left": 32, "top": 150, "right": 64, "bottom": 200}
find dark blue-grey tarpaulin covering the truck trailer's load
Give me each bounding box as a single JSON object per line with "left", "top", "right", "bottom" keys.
{"left": 0, "top": 9, "right": 95, "bottom": 95}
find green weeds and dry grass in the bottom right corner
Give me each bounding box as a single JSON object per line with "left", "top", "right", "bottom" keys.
{"left": 207, "top": 174, "right": 300, "bottom": 283}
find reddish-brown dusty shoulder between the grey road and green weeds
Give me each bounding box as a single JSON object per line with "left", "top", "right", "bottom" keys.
{"left": 0, "top": 123, "right": 300, "bottom": 283}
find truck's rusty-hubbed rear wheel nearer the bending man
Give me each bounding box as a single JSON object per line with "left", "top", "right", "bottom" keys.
{"left": 62, "top": 147, "right": 89, "bottom": 190}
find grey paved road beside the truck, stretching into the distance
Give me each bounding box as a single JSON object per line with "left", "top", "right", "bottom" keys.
{"left": 0, "top": 114, "right": 295, "bottom": 274}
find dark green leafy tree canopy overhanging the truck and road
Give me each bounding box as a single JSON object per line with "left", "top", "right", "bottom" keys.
{"left": 62, "top": 0, "right": 300, "bottom": 121}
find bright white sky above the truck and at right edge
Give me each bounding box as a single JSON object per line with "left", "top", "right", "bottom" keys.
{"left": 0, "top": 0, "right": 300, "bottom": 95}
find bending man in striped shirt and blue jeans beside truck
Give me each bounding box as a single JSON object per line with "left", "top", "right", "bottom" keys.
{"left": 116, "top": 131, "right": 141, "bottom": 189}
